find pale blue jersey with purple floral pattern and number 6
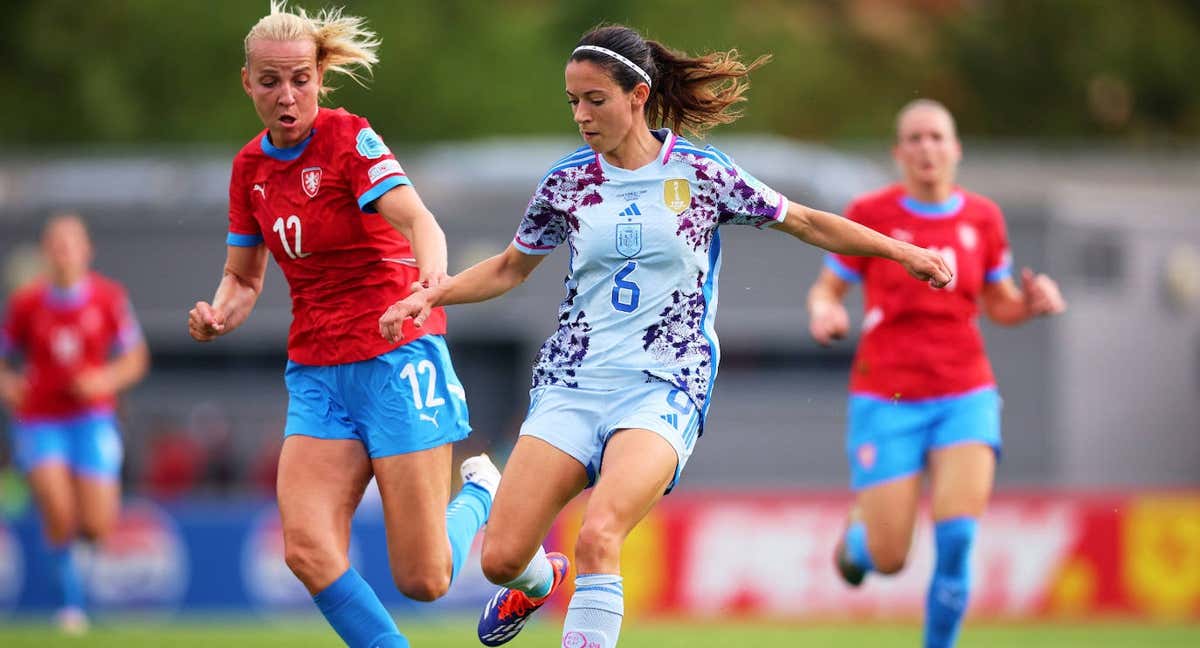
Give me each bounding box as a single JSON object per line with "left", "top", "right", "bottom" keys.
{"left": 514, "top": 128, "right": 787, "bottom": 420}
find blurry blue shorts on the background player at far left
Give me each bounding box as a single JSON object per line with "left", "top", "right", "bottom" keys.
{"left": 12, "top": 412, "right": 125, "bottom": 479}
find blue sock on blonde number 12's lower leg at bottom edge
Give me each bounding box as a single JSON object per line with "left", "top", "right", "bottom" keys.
{"left": 312, "top": 568, "right": 408, "bottom": 648}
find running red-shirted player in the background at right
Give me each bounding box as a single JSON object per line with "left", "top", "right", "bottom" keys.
{"left": 808, "top": 100, "right": 1066, "bottom": 648}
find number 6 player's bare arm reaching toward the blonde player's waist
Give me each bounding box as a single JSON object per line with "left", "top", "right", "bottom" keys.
{"left": 379, "top": 245, "right": 546, "bottom": 342}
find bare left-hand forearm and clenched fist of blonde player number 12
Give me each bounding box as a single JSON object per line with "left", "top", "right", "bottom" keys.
{"left": 187, "top": 244, "right": 266, "bottom": 342}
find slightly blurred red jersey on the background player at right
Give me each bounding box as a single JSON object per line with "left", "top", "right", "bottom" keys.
{"left": 826, "top": 185, "right": 1012, "bottom": 401}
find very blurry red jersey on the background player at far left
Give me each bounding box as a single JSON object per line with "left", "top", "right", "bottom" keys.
{"left": 0, "top": 272, "right": 142, "bottom": 420}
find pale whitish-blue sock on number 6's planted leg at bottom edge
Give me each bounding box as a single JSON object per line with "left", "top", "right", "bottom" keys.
{"left": 563, "top": 574, "right": 625, "bottom": 648}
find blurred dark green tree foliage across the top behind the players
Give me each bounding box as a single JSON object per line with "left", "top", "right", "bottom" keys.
{"left": 0, "top": 0, "right": 1200, "bottom": 150}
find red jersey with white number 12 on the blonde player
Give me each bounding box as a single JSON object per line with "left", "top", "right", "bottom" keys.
{"left": 228, "top": 108, "right": 445, "bottom": 365}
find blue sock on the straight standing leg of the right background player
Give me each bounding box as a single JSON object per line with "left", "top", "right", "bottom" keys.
{"left": 925, "top": 517, "right": 978, "bottom": 648}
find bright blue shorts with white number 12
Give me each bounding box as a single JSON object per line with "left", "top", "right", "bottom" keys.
{"left": 283, "top": 335, "right": 470, "bottom": 458}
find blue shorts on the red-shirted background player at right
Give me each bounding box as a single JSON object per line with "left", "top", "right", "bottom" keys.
{"left": 846, "top": 386, "right": 1001, "bottom": 491}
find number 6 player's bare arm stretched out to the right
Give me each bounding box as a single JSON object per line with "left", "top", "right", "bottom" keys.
{"left": 772, "top": 202, "right": 954, "bottom": 288}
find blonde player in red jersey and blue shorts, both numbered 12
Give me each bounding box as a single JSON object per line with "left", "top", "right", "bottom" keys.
{"left": 188, "top": 2, "right": 499, "bottom": 648}
